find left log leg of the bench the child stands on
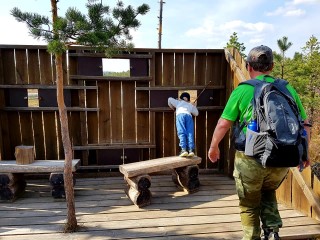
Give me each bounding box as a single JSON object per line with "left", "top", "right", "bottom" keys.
{"left": 125, "top": 174, "right": 152, "bottom": 208}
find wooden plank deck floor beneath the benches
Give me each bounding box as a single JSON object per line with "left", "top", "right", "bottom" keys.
{"left": 0, "top": 174, "right": 320, "bottom": 240}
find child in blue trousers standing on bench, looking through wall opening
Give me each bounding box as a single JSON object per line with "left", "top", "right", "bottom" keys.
{"left": 168, "top": 92, "right": 199, "bottom": 157}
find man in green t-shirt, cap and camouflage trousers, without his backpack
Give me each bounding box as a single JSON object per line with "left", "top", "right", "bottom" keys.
{"left": 208, "top": 45, "right": 310, "bottom": 240}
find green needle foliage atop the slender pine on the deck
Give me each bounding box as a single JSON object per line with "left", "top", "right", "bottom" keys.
{"left": 11, "top": 0, "right": 150, "bottom": 56}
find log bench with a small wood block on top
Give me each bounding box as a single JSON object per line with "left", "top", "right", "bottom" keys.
{"left": 0, "top": 159, "right": 80, "bottom": 201}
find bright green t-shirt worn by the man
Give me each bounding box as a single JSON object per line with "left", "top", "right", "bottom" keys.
{"left": 221, "top": 75, "right": 307, "bottom": 128}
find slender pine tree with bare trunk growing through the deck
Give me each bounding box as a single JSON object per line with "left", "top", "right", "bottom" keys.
{"left": 11, "top": 0, "right": 149, "bottom": 232}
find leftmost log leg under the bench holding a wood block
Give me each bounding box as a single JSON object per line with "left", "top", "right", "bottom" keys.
{"left": 0, "top": 173, "right": 27, "bottom": 201}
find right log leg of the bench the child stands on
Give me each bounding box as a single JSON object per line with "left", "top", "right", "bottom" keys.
{"left": 172, "top": 165, "right": 200, "bottom": 193}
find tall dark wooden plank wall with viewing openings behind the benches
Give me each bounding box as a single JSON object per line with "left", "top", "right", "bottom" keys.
{"left": 0, "top": 45, "right": 232, "bottom": 171}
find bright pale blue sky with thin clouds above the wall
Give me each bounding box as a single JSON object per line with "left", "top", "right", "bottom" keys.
{"left": 0, "top": 0, "right": 320, "bottom": 71}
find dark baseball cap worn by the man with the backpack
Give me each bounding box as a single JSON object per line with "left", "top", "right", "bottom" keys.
{"left": 247, "top": 45, "right": 273, "bottom": 64}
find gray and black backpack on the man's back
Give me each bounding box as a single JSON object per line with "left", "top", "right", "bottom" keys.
{"left": 240, "top": 79, "right": 308, "bottom": 167}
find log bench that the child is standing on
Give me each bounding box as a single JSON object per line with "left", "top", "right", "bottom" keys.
{"left": 119, "top": 156, "right": 201, "bottom": 207}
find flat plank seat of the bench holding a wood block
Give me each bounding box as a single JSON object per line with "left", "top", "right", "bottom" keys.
{"left": 0, "top": 159, "right": 80, "bottom": 173}
